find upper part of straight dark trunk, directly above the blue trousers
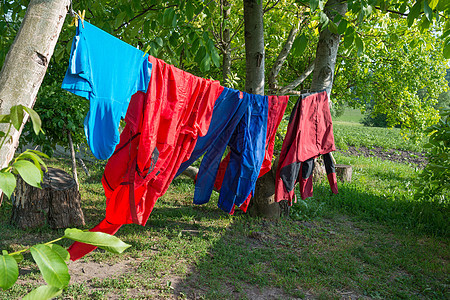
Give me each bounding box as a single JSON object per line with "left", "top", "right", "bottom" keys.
{"left": 244, "top": 0, "right": 265, "bottom": 95}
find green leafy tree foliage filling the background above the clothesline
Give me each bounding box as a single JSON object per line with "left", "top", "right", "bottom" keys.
{"left": 0, "top": 0, "right": 450, "bottom": 149}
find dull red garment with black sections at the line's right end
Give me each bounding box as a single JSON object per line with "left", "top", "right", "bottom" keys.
{"left": 275, "top": 91, "right": 338, "bottom": 205}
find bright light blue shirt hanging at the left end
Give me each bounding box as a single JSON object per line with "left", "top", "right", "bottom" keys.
{"left": 61, "top": 21, "right": 152, "bottom": 159}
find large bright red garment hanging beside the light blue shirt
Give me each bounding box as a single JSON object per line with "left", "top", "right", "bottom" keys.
{"left": 68, "top": 56, "right": 223, "bottom": 260}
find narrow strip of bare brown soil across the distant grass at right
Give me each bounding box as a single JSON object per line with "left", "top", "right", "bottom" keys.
{"left": 338, "top": 146, "right": 428, "bottom": 168}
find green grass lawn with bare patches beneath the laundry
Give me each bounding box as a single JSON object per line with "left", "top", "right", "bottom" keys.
{"left": 0, "top": 106, "right": 450, "bottom": 299}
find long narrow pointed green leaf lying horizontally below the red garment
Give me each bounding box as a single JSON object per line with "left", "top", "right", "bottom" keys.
{"left": 64, "top": 228, "right": 131, "bottom": 253}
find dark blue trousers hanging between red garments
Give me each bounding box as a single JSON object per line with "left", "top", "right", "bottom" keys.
{"left": 177, "top": 88, "right": 268, "bottom": 213}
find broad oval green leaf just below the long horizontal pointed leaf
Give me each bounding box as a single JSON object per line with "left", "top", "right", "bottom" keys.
{"left": 30, "top": 244, "right": 70, "bottom": 289}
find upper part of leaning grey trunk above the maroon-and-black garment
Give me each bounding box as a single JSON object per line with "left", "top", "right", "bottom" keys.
{"left": 311, "top": 0, "right": 347, "bottom": 95}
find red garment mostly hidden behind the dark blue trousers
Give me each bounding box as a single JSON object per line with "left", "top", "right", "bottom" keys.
{"left": 214, "top": 96, "right": 289, "bottom": 215}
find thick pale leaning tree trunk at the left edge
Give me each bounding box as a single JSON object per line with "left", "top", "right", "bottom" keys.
{"left": 0, "top": 0, "right": 70, "bottom": 169}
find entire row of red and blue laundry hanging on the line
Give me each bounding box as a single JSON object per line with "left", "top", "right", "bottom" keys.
{"left": 62, "top": 21, "right": 337, "bottom": 260}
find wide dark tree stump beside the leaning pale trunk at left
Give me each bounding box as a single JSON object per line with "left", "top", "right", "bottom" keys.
{"left": 11, "top": 168, "right": 85, "bottom": 229}
